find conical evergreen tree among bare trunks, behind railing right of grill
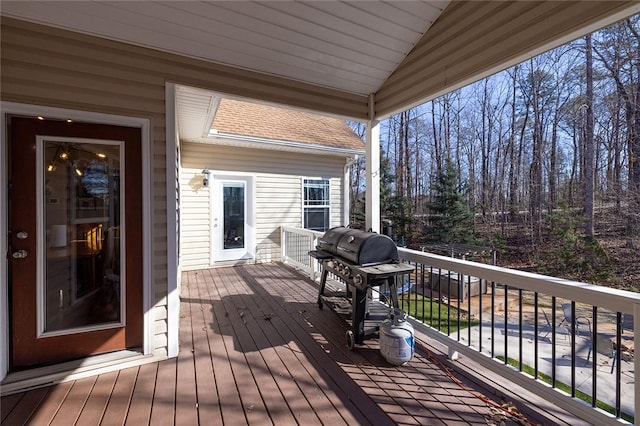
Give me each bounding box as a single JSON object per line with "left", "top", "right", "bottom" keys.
{"left": 426, "top": 158, "right": 475, "bottom": 243}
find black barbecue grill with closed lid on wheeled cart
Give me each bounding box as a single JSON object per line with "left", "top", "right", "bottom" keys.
{"left": 309, "top": 227, "right": 413, "bottom": 349}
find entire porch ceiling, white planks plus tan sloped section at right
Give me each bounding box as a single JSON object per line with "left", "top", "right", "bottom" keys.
{"left": 1, "top": 0, "right": 640, "bottom": 119}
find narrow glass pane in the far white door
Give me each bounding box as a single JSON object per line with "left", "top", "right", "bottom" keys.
{"left": 222, "top": 182, "right": 245, "bottom": 250}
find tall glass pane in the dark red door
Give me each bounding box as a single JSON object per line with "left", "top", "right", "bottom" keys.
{"left": 40, "top": 140, "right": 123, "bottom": 333}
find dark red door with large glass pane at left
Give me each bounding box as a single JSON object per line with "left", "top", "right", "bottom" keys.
{"left": 9, "top": 117, "right": 143, "bottom": 369}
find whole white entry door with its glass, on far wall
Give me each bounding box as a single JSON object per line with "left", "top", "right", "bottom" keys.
{"left": 211, "top": 174, "right": 255, "bottom": 263}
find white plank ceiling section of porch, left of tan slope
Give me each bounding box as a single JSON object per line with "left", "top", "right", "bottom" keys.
{"left": 1, "top": 1, "right": 449, "bottom": 95}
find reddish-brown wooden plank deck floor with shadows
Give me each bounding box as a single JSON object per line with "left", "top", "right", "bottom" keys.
{"left": 0, "top": 264, "right": 580, "bottom": 426}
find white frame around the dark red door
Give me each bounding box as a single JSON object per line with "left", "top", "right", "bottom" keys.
{"left": 0, "top": 102, "right": 154, "bottom": 380}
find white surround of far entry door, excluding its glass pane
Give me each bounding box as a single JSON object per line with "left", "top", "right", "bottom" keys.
{"left": 209, "top": 171, "right": 256, "bottom": 265}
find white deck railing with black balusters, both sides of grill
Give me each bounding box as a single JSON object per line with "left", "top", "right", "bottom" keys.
{"left": 281, "top": 227, "right": 640, "bottom": 424}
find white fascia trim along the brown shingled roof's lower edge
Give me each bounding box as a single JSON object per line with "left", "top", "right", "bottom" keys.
{"left": 205, "top": 132, "right": 365, "bottom": 157}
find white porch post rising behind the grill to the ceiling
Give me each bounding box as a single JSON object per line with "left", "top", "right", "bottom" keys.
{"left": 365, "top": 93, "right": 380, "bottom": 232}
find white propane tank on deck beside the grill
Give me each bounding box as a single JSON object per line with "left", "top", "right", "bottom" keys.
{"left": 380, "top": 308, "right": 414, "bottom": 365}
